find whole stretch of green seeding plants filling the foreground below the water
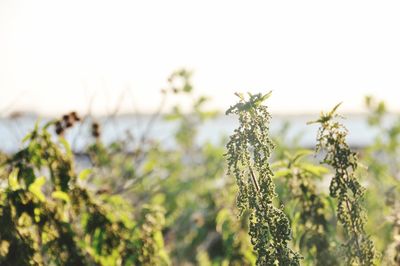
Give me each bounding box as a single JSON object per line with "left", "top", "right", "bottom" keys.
{"left": 0, "top": 70, "right": 400, "bottom": 266}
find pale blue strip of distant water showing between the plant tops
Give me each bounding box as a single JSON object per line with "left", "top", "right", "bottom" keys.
{"left": 0, "top": 115, "right": 394, "bottom": 153}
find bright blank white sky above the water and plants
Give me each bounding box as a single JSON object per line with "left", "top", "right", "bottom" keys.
{"left": 0, "top": 0, "right": 400, "bottom": 114}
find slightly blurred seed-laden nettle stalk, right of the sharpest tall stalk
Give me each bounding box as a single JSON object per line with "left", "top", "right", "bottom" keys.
{"left": 314, "top": 105, "right": 376, "bottom": 265}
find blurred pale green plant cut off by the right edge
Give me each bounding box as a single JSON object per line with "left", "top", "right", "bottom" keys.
{"left": 363, "top": 96, "right": 400, "bottom": 265}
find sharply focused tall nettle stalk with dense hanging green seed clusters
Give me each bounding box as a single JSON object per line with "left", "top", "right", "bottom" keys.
{"left": 226, "top": 94, "right": 300, "bottom": 265}
